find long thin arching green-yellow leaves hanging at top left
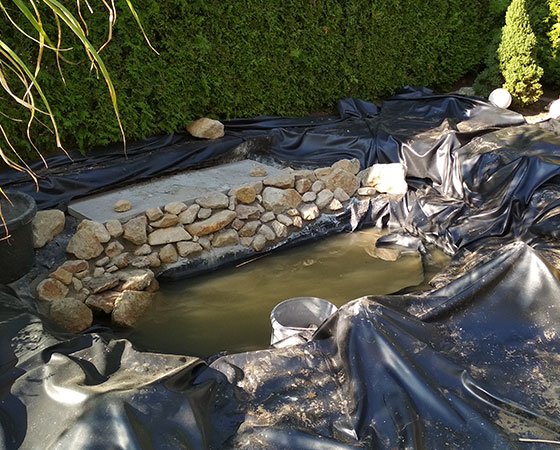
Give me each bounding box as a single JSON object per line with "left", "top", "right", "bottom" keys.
{"left": 0, "top": 0, "right": 157, "bottom": 237}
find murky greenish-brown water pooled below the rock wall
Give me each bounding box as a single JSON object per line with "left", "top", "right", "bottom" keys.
{"left": 129, "top": 230, "right": 445, "bottom": 357}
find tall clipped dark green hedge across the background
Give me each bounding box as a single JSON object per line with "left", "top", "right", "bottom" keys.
{"left": 0, "top": 0, "right": 489, "bottom": 160}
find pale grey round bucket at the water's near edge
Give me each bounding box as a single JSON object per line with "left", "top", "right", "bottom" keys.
{"left": 270, "top": 297, "right": 338, "bottom": 348}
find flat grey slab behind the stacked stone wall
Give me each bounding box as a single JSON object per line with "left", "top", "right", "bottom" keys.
{"left": 68, "top": 159, "right": 281, "bottom": 223}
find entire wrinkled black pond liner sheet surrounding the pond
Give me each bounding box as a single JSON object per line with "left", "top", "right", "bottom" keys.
{"left": 0, "top": 89, "right": 560, "bottom": 449}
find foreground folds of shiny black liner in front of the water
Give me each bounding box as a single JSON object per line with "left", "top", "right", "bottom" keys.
{"left": 0, "top": 243, "right": 560, "bottom": 449}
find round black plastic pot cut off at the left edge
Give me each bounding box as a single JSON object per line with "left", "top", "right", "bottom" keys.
{"left": 0, "top": 192, "right": 37, "bottom": 284}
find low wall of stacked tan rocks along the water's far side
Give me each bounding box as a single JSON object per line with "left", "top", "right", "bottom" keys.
{"left": 32, "top": 159, "right": 407, "bottom": 332}
